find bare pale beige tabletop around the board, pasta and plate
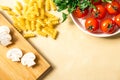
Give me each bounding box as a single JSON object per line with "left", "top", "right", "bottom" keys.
{"left": 0, "top": 0, "right": 120, "bottom": 80}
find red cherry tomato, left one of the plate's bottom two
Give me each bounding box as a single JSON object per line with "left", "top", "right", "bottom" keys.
{"left": 85, "top": 17, "right": 99, "bottom": 32}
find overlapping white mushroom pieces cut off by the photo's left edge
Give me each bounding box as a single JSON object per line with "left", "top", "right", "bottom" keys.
{"left": 0, "top": 26, "right": 12, "bottom": 46}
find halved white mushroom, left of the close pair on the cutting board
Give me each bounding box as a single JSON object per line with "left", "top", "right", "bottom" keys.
{"left": 7, "top": 48, "right": 23, "bottom": 61}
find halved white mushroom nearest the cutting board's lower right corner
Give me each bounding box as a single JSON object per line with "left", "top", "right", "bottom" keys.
{"left": 21, "top": 52, "right": 36, "bottom": 67}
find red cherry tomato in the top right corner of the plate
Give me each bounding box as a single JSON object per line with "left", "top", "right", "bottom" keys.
{"left": 106, "top": 1, "right": 120, "bottom": 15}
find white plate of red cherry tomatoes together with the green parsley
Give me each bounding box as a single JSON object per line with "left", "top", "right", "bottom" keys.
{"left": 54, "top": 0, "right": 120, "bottom": 37}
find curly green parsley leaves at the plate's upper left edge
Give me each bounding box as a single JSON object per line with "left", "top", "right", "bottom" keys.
{"left": 53, "top": 0, "right": 112, "bottom": 22}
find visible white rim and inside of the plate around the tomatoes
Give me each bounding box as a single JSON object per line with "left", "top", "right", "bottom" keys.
{"left": 70, "top": 14, "right": 120, "bottom": 37}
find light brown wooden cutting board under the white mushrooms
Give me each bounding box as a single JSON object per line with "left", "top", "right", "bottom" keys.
{"left": 0, "top": 13, "right": 50, "bottom": 80}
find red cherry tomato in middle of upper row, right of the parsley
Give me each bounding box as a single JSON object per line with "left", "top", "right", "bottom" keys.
{"left": 92, "top": 5, "right": 106, "bottom": 19}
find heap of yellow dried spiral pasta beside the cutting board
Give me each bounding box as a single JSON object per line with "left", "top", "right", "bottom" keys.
{"left": 0, "top": 0, "right": 59, "bottom": 39}
